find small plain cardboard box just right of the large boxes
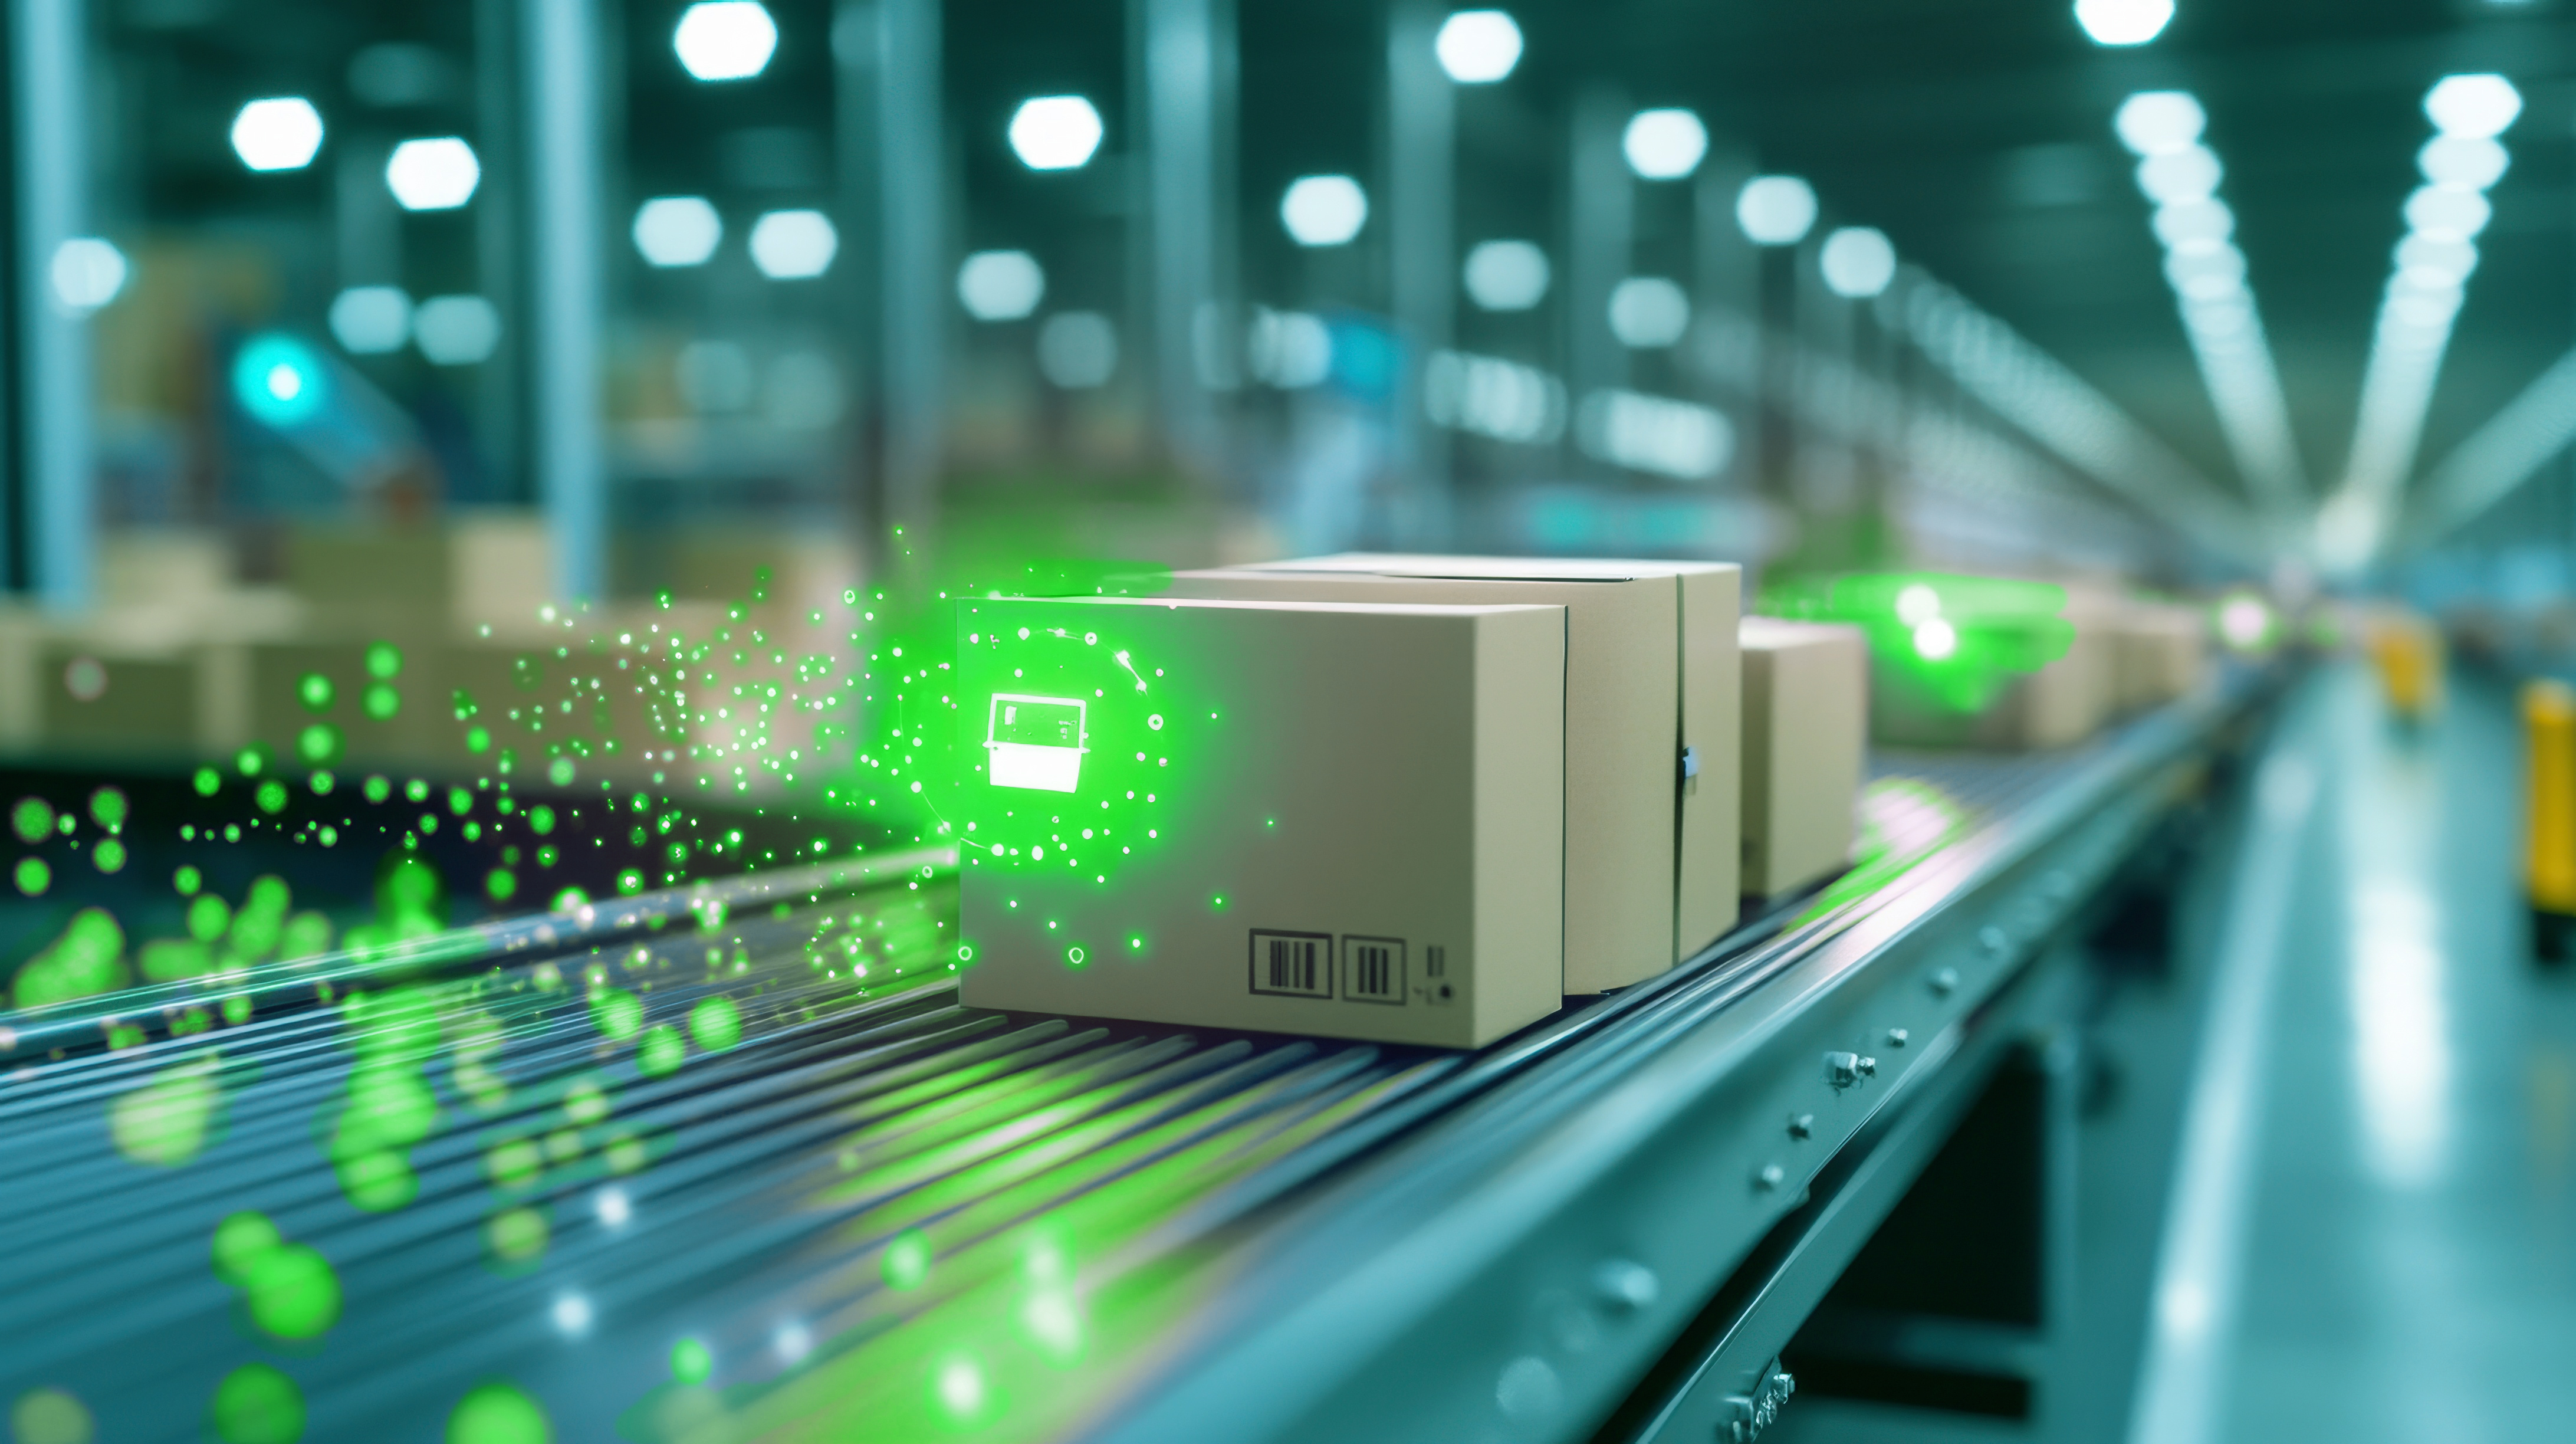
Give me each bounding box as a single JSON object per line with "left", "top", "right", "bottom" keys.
{"left": 1736, "top": 616, "right": 1870, "bottom": 897}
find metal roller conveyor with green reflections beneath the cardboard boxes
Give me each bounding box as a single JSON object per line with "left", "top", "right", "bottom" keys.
{"left": 0, "top": 688, "right": 2241, "bottom": 1444}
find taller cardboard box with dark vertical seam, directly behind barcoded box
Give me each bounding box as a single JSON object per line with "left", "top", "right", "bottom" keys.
{"left": 1172, "top": 552, "right": 1744, "bottom": 993}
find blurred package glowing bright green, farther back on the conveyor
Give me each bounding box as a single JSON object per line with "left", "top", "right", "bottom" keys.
{"left": 1765, "top": 572, "right": 2112, "bottom": 750}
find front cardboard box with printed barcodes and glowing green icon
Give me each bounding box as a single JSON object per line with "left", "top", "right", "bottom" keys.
{"left": 958, "top": 598, "right": 1566, "bottom": 1047}
